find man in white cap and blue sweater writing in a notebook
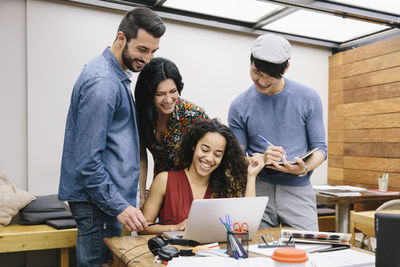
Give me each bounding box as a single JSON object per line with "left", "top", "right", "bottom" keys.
{"left": 228, "top": 34, "right": 327, "bottom": 231}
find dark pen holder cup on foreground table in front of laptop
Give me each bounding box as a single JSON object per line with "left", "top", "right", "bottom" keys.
{"left": 226, "top": 231, "right": 249, "bottom": 259}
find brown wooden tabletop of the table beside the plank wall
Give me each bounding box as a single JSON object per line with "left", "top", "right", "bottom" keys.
{"left": 316, "top": 192, "right": 400, "bottom": 205}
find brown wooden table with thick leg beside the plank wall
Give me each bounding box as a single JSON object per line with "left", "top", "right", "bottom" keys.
{"left": 316, "top": 192, "right": 400, "bottom": 233}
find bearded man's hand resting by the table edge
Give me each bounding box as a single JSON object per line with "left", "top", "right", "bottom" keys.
{"left": 117, "top": 206, "right": 148, "bottom": 232}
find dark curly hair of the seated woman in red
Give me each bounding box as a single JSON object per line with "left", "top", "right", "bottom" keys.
{"left": 175, "top": 119, "right": 247, "bottom": 198}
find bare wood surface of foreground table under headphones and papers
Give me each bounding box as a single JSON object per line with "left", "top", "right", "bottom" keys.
{"left": 104, "top": 228, "right": 281, "bottom": 267}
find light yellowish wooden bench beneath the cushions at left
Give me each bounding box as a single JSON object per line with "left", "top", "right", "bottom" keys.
{"left": 0, "top": 224, "right": 77, "bottom": 267}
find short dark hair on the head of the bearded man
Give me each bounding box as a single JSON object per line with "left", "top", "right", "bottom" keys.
{"left": 118, "top": 7, "right": 165, "bottom": 42}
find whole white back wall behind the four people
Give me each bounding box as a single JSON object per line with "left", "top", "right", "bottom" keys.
{"left": 0, "top": 0, "right": 331, "bottom": 197}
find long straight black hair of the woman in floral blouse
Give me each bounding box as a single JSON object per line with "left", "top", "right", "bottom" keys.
{"left": 135, "top": 57, "right": 183, "bottom": 142}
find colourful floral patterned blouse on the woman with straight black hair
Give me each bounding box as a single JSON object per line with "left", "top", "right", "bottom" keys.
{"left": 146, "top": 98, "right": 208, "bottom": 176}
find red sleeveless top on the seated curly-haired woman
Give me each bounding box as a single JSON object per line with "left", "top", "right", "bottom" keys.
{"left": 159, "top": 170, "right": 211, "bottom": 224}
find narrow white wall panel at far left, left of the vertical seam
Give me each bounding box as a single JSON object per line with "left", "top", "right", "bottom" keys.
{"left": 0, "top": 0, "right": 28, "bottom": 189}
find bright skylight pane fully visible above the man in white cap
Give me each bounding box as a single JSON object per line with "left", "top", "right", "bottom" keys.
{"left": 263, "top": 10, "right": 389, "bottom": 43}
